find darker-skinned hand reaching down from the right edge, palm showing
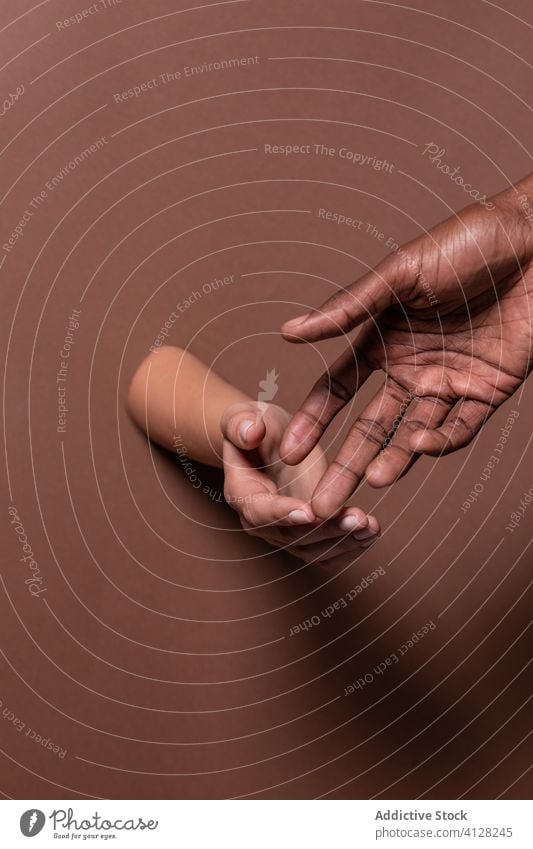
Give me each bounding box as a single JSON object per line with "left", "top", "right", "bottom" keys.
{"left": 281, "top": 177, "right": 533, "bottom": 518}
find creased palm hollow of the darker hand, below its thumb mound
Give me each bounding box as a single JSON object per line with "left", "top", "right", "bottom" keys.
{"left": 366, "top": 270, "right": 533, "bottom": 406}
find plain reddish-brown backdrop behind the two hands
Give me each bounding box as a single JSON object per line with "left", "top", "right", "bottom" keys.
{"left": 0, "top": 0, "right": 533, "bottom": 798}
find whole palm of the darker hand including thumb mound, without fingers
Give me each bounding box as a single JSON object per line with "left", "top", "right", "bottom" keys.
{"left": 374, "top": 198, "right": 533, "bottom": 390}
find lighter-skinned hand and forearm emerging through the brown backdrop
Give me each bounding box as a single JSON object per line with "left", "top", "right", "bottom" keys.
{"left": 127, "top": 346, "right": 379, "bottom": 563}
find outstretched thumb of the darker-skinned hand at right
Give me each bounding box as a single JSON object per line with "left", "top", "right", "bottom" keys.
{"left": 281, "top": 251, "right": 417, "bottom": 342}
